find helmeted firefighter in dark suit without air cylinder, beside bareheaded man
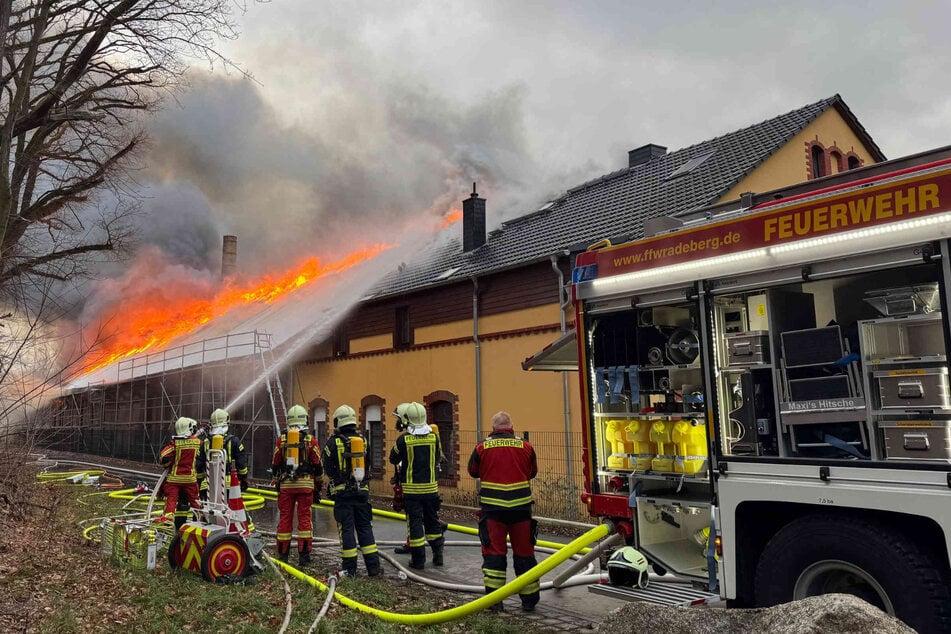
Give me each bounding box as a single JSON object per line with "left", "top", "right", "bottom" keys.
{"left": 390, "top": 402, "right": 445, "bottom": 570}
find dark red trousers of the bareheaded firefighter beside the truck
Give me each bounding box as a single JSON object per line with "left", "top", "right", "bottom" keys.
{"left": 479, "top": 514, "right": 539, "bottom": 608}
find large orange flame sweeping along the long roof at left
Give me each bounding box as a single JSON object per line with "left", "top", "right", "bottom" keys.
{"left": 82, "top": 244, "right": 394, "bottom": 373}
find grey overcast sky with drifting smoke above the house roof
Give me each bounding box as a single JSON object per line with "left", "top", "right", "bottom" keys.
{"left": 102, "top": 0, "right": 951, "bottom": 292}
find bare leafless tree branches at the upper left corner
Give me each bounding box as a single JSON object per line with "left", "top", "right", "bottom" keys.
{"left": 0, "top": 0, "right": 242, "bottom": 292}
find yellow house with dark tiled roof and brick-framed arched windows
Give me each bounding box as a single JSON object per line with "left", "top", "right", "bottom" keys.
{"left": 293, "top": 95, "right": 885, "bottom": 517}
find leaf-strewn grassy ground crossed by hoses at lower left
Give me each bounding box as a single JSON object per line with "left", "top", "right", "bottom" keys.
{"left": 0, "top": 466, "right": 552, "bottom": 634}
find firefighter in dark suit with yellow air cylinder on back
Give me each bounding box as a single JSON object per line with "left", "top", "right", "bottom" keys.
{"left": 323, "top": 405, "right": 383, "bottom": 577}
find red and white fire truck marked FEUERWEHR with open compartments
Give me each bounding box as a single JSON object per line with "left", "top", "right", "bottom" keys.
{"left": 571, "top": 158, "right": 951, "bottom": 632}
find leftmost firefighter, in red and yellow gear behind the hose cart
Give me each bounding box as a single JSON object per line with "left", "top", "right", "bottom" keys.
{"left": 158, "top": 416, "right": 205, "bottom": 529}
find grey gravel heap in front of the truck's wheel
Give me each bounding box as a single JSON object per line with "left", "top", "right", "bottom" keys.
{"left": 597, "top": 594, "right": 915, "bottom": 634}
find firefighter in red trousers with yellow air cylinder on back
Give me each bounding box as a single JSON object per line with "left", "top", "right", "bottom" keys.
{"left": 271, "top": 405, "right": 323, "bottom": 566}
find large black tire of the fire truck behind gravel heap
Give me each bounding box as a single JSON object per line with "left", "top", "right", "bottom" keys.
{"left": 754, "top": 515, "right": 951, "bottom": 632}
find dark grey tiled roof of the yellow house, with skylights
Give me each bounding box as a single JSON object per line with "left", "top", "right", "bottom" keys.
{"left": 374, "top": 95, "right": 885, "bottom": 299}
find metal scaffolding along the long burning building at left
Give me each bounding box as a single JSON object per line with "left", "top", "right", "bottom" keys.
{"left": 38, "top": 331, "right": 290, "bottom": 477}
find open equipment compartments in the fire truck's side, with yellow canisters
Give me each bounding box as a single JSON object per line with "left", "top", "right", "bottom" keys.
{"left": 584, "top": 239, "right": 951, "bottom": 581}
